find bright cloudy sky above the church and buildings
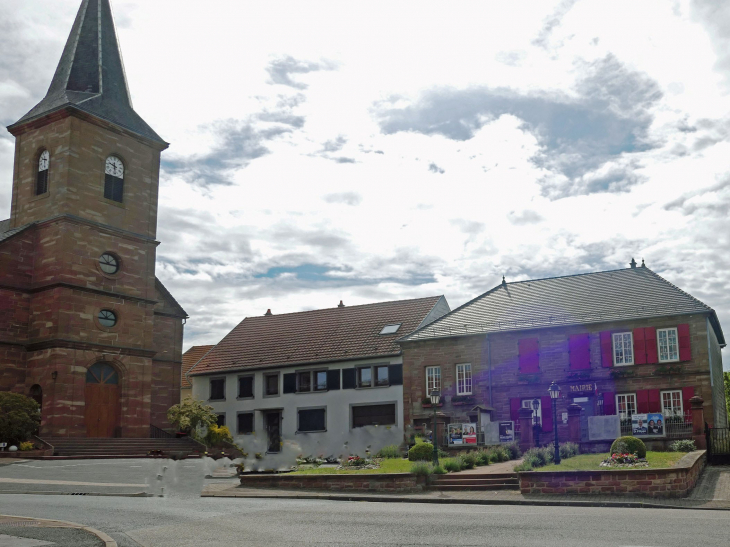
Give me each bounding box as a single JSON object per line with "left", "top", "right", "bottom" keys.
{"left": 0, "top": 0, "right": 730, "bottom": 369}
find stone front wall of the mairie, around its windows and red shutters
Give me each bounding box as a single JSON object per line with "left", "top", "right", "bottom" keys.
{"left": 403, "top": 314, "right": 721, "bottom": 440}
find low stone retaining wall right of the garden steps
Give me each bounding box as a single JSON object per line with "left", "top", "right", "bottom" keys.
{"left": 519, "top": 450, "right": 706, "bottom": 498}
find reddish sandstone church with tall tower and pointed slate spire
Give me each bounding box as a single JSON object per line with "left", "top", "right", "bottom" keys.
{"left": 0, "top": 0, "right": 187, "bottom": 437}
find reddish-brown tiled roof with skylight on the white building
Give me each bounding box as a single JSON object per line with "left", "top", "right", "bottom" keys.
{"left": 191, "top": 296, "right": 448, "bottom": 376}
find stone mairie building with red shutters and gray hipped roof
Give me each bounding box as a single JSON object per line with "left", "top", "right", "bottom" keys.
{"left": 400, "top": 265, "right": 727, "bottom": 448}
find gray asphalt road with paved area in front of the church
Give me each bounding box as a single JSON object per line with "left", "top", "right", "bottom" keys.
{"left": 0, "top": 460, "right": 730, "bottom": 547}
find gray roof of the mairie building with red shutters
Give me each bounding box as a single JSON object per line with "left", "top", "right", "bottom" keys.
{"left": 400, "top": 266, "right": 725, "bottom": 344}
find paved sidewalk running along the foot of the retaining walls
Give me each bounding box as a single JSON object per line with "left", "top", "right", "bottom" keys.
{"left": 201, "top": 466, "right": 730, "bottom": 510}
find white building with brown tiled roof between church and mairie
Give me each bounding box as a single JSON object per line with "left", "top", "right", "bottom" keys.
{"left": 188, "top": 296, "right": 449, "bottom": 468}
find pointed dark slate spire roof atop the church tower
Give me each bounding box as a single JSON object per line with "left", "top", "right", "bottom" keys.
{"left": 8, "top": 0, "right": 167, "bottom": 144}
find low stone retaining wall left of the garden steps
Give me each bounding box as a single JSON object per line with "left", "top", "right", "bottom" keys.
{"left": 241, "top": 473, "right": 426, "bottom": 492}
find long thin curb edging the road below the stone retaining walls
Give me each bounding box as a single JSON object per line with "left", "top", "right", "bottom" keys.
{"left": 200, "top": 492, "right": 730, "bottom": 511}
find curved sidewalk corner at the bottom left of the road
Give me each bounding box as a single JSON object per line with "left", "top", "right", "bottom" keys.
{"left": 0, "top": 515, "right": 117, "bottom": 547}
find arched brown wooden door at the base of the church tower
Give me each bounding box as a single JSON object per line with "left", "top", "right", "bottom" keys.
{"left": 85, "top": 363, "right": 119, "bottom": 437}
